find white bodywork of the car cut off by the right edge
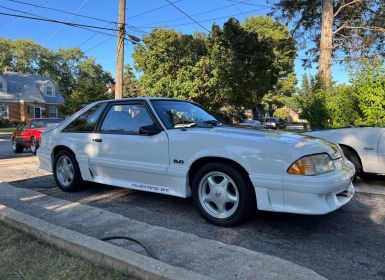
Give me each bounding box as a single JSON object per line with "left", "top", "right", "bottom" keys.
{"left": 306, "top": 127, "right": 385, "bottom": 178}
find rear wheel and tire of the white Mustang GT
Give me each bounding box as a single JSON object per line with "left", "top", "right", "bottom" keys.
{"left": 53, "top": 150, "right": 83, "bottom": 192}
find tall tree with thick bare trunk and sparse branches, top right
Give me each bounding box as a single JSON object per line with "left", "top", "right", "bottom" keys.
{"left": 273, "top": 0, "right": 385, "bottom": 88}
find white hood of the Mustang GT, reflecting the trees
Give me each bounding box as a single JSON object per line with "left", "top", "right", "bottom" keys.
{"left": 196, "top": 126, "right": 341, "bottom": 159}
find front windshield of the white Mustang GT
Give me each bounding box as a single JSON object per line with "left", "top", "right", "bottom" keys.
{"left": 151, "top": 100, "right": 220, "bottom": 129}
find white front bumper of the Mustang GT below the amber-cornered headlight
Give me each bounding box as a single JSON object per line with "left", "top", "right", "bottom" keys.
{"left": 250, "top": 162, "right": 354, "bottom": 215}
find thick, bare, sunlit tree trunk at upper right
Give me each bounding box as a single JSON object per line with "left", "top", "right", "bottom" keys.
{"left": 318, "top": 0, "right": 334, "bottom": 88}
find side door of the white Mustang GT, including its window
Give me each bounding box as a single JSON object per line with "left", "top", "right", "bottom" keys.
{"left": 89, "top": 101, "right": 169, "bottom": 193}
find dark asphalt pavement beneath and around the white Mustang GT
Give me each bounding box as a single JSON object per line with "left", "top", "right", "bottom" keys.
{"left": 0, "top": 137, "right": 385, "bottom": 279}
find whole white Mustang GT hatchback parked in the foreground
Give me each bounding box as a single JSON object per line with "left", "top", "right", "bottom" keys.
{"left": 38, "top": 98, "right": 354, "bottom": 226}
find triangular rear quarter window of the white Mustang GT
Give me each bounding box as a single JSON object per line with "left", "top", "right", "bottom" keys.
{"left": 63, "top": 103, "right": 106, "bottom": 132}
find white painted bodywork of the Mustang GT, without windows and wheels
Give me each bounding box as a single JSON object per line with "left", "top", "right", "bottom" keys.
{"left": 38, "top": 98, "right": 354, "bottom": 214}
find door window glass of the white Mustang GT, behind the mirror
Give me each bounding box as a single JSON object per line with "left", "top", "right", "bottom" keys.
{"left": 100, "top": 104, "right": 153, "bottom": 134}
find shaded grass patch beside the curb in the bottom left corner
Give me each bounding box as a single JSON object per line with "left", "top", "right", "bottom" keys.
{"left": 0, "top": 222, "right": 133, "bottom": 280}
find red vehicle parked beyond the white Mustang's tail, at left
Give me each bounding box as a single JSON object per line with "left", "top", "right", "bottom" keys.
{"left": 11, "top": 118, "right": 63, "bottom": 155}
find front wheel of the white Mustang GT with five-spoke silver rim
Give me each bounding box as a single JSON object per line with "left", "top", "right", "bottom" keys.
{"left": 192, "top": 162, "right": 256, "bottom": 226}
